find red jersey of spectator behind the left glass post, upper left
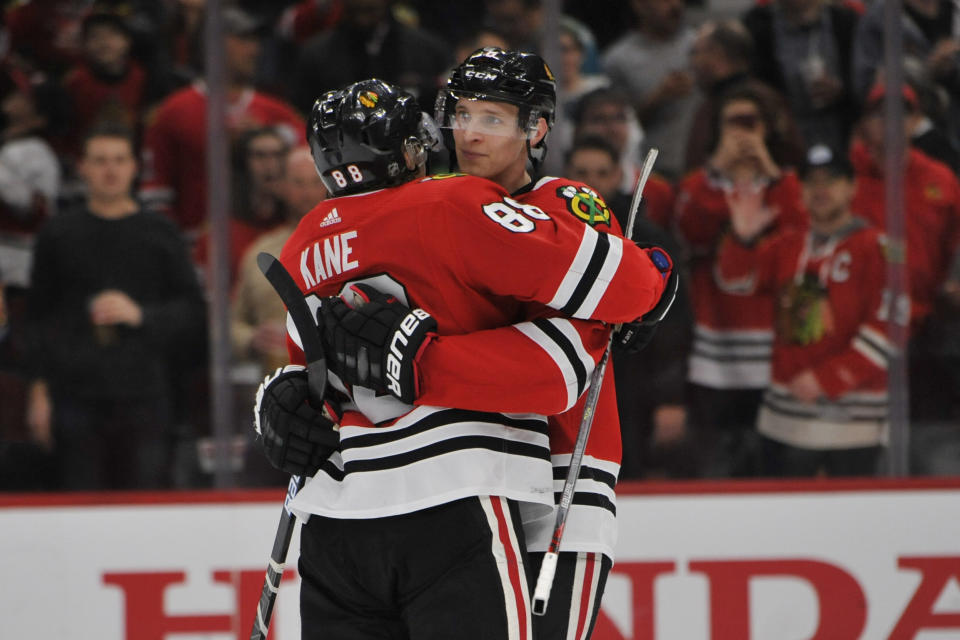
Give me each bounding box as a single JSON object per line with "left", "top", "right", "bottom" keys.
{"left": 141, "top": 83, "right": 306, "bottom": 234}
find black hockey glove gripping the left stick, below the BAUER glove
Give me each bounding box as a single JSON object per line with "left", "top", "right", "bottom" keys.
{"left": 253, "top": 365, "right": 340, "bottom": 476}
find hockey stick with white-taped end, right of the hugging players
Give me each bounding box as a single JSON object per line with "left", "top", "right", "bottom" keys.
{"left": 533, "top": 149, "right": 659, "bottom": 616}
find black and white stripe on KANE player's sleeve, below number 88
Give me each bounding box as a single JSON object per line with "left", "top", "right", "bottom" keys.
{"left": 549, "top": 225, "right": 623, "bottom": 319}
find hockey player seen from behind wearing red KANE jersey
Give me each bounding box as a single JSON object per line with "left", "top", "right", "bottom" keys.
{"left": 256, "top": 81, "right": 676, "bottom": 639}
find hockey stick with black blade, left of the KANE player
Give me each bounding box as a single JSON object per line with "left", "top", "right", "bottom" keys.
{"left": 250, "top": 253, "right": 327, "bottom": 640}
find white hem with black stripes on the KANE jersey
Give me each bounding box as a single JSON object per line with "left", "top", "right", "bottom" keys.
{"left": 291, "top": 406, "right": 553, "bottom": 518}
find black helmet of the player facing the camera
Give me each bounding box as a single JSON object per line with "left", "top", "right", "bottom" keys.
{"left": 435, "top": 47, "right": 557, "bottom": 136}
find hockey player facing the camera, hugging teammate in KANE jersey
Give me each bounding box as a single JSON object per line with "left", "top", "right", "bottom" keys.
{"left": 316, "top": 48, "right": 667, "bottom": 638}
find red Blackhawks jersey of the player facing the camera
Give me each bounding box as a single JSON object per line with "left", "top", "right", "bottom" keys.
{"left": 417, "top": 177, "right": 621, "bottom": 558}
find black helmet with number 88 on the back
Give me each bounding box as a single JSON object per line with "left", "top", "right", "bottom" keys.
{"left": 307, "top": 78, "right": 439, "bottom": 196}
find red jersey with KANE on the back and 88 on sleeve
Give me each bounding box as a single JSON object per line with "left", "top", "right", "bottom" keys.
{"left": 281, "top": 176, "right": 663, "bottom": 520}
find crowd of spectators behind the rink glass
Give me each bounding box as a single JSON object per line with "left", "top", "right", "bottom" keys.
{"left": 0, "top": 0, "right": 960, "bottom": 489}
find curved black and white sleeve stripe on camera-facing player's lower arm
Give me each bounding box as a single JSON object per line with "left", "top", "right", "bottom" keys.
{"left": 515, "top": 318, "right": 594, "bottom": 411}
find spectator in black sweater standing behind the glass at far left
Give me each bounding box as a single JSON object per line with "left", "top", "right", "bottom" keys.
{"left": 27, "top": 129, "right": 204, "bottom": 490}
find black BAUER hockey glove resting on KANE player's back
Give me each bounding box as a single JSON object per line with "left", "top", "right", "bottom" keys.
{"left": 319, "top": 284, "right": 437, "bottom": 404}
